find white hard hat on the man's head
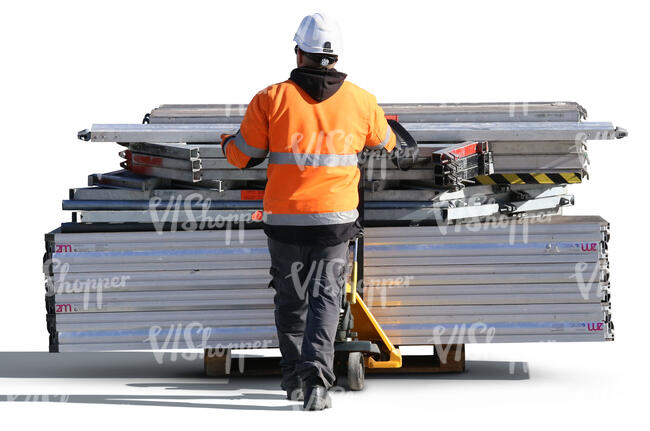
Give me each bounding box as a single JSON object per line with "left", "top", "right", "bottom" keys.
{"left": 293, "top": 13, "right": 342, "bottom": 55}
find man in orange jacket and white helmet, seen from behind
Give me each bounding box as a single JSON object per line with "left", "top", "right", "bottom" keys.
{"left": 222, "top": 13, "right": 396, "bottom": 410}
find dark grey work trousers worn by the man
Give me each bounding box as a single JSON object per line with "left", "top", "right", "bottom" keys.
{"left": 268, "top": 238, "right": 349, "bottom": 390}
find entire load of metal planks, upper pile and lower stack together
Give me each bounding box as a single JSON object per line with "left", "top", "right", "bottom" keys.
{"left": 39, "top": 102, "right": 626, "bottom": 352}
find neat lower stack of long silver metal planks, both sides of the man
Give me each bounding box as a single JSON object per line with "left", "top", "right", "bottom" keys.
{"left": 44, "top": 217, "right": 613, "bottom": 352}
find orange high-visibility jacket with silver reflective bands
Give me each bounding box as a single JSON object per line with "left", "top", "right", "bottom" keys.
{"left": 222, "top": 74, "right": 396, "bottom": 230}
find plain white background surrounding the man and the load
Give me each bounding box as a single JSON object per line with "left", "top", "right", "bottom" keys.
{"left": 0, "top": 0, "right": 650, "bottom": 429}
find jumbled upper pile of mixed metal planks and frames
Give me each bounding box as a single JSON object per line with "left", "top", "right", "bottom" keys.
{"left": 72, "top": 102, "right": 626, "bottom": 225}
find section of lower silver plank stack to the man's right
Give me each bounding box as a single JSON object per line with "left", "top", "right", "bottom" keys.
{"left": 364, "top": 216, "right": 613, "bottom": 345}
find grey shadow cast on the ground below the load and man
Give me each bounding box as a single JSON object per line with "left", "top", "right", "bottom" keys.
{"left": 0, "top": 352, "right": 529, "bottom": 411}
